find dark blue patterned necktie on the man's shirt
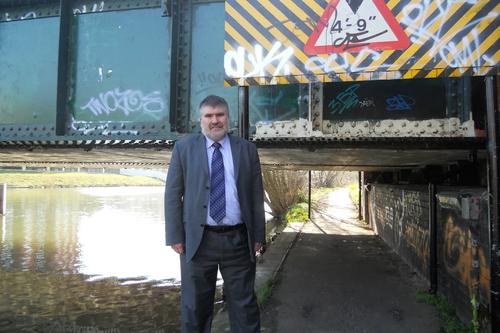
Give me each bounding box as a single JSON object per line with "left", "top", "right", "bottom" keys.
{"left": 210, "top": 142, "right": 226, "bottom": 223}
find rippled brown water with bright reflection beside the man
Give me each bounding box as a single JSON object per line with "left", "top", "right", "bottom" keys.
{"left": 0, "top": 187, "right": 279, "bottom": 333}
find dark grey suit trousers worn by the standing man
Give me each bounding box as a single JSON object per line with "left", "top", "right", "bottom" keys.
{"left": 181, "top": 227, "right": 260, "bottom": 333}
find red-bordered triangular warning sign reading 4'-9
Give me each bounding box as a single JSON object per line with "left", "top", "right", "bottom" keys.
{"left": 304, "top": 0, "right": 410, "bottom": 55}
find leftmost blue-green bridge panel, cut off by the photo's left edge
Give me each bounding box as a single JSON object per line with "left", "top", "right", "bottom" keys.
{"left": 0, "top": 17, "right": 59, "bottom": 138}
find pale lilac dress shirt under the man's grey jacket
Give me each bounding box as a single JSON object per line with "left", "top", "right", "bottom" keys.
{"left": 205, "top": 135, "right": 241, "bottom": 226}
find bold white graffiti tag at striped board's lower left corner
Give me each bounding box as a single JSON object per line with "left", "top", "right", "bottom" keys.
{"left": 224, "top": 42, "right": 294, "bottom": 78}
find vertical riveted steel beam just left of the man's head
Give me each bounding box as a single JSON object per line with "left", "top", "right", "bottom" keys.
{"left": 170, "top": 0, "right": 193, "bottom": 133}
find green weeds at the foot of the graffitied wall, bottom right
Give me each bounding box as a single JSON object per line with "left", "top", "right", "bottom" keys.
{"left": 417, "top": 289, "right": 477, "bottom": 333}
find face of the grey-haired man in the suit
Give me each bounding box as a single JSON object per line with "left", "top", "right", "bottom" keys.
{"left": 200, "top": 106, "right": 229, "bottom": 141}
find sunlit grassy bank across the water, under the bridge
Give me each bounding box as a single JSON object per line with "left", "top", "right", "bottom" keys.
{"left": 0, "top": 171, "right": 165, "bottom": 187}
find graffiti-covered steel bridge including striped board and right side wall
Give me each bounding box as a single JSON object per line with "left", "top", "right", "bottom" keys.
{"left": 0, "top": 0, "right": 500, "bottom": 332}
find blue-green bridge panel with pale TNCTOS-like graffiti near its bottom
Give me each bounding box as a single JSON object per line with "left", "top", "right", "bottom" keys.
{"left": 69, "top": 8, "right": 170, "bottom": 136}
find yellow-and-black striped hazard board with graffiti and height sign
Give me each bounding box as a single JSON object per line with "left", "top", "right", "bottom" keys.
{"left": 224, "top": 0, "right": 500, "bottom": 86}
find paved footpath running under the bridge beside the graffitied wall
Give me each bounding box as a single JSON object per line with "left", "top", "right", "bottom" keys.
{"left": 212, "top": 189, "right": 440, "bottom": 333}
